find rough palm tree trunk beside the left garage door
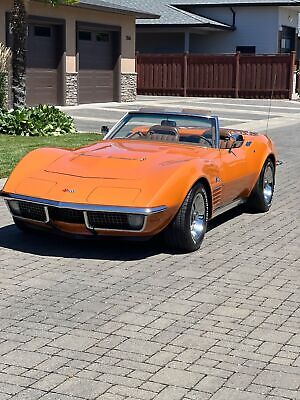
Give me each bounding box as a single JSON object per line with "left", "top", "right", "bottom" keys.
{"left": 10, "top": 0, "right": 77, "bottom": 108}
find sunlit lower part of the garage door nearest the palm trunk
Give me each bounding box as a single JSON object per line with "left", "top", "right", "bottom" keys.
{"left": 26, "top": 68, "right": 58, "bottom": 105}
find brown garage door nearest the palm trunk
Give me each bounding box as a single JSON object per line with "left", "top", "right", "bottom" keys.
{"left": 26, "top": 23, "right": 63, "bottom": 105}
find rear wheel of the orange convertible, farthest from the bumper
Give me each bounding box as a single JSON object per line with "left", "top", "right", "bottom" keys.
{"left": 248, "top": 158, "right": 275, "bottom": 212}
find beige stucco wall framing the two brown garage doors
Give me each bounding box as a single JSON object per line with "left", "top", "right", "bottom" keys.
{"left": 0, "top": 0, "right": 135, "bottom": 73}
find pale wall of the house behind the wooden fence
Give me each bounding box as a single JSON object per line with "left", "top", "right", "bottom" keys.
{"left": 190, "top": 6, "right": 279, "bottom": 54}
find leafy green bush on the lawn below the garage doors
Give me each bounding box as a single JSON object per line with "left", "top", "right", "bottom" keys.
{"left": 0, "top": 105, "right": 76, "bottom": 136}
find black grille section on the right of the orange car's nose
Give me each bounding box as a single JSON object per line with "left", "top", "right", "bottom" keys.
{"left": 87, "top": 211, "right": 137, "bottom": 231}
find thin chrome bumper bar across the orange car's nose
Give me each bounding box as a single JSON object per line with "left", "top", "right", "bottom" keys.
{"left": 0, "top": 192, "right": 167, "bottom": 216}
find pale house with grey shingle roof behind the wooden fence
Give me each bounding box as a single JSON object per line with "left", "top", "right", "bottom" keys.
{"left": 105, "top": 0, "right": 300, "bottom": 58}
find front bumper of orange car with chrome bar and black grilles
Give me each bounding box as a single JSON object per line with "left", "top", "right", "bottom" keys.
{"left": 0, "top": 192, "right": 167, "bottom": 235}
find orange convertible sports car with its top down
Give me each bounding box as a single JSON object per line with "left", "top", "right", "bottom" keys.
{"left": 0, "top": 110, "right": 276, "bottom": 251}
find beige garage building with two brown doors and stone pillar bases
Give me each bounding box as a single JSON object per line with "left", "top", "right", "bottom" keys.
{"left": 0, "top": 0, "right": 155, "bottom": 105}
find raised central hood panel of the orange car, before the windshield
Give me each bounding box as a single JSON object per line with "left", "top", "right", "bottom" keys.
{"left": 45, "top": 140, "right": 205, "bottom": 181}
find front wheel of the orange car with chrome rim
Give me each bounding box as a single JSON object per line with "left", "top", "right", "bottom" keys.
{"left": 164, "top": 184, "right": 208, "bottom": 252}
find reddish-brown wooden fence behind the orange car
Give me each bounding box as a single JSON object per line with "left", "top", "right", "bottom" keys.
{"left": 137, "top": 52, "right": 295, "bottom": 99}
